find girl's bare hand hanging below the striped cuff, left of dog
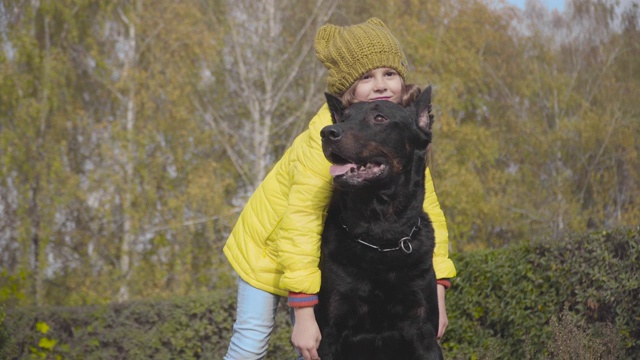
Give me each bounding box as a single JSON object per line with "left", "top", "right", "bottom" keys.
{"left": 291, "top": 307, "right": 322, "bottom": 360}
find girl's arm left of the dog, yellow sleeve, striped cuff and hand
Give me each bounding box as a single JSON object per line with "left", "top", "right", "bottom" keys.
{"left": 278, "top": 105, "right": 333, "bottom": 360}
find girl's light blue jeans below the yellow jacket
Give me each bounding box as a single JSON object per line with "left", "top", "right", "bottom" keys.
{"left": 224, "top": 277, "right": 302, "bottom": 360}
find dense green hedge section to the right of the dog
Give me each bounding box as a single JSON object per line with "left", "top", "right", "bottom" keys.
{"left": 444, "top": 228, "right": 640, "bottom": 359}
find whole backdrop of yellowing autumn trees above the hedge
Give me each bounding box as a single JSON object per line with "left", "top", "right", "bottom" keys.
{"left": 0, "top": 0, "right": 640, "bottom": 307}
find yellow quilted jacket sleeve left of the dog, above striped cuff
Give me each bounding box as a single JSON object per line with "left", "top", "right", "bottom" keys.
{"left": 278, "top": 105, "right": 333, "bottom": 294}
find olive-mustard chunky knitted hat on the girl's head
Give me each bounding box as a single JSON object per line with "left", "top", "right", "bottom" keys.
{"left": 315, "top": 18, "right": 407, "bottom": 95}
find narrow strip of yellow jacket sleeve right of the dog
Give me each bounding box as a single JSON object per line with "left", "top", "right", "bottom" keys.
{"left": 423, "top": 167, "right": 456, "bottom": 280}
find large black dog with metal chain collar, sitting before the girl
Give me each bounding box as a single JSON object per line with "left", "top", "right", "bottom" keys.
{"left": 316, "top": 87, "right": 442, "bottom": 360}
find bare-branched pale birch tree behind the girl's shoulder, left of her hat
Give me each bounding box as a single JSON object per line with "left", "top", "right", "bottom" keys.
{"left": 195, "top": 0, "right": 337, "bottom": 198}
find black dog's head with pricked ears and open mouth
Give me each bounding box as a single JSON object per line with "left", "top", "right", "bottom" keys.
{"left": 320, "top": 86, "right": 433, "bottom": 188}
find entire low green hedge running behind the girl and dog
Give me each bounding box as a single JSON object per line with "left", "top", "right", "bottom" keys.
{"left": 0, "top": 228, "right": 640, "bottom": 359}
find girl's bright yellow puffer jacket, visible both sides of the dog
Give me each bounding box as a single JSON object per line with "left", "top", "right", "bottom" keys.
{"left": 224, "top": 104, "right": 456, "bottom": 296}
